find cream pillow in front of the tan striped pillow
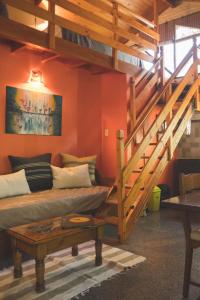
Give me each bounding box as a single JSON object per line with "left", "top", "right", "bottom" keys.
{"left": 51, "top": 164, "right": 92, "bottom": 189}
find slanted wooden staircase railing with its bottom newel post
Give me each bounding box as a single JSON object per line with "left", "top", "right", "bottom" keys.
{"left": 117, "top": 40, "right": 200, "bottom": 240}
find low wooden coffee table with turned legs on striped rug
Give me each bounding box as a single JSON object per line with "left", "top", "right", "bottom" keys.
{"left": 8, "top": 217, "right": 105, "bottom": 293}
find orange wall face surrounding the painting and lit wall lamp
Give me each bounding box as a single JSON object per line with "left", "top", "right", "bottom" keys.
{"left": 0, "top": 46, "right": 78, "bottom": 174}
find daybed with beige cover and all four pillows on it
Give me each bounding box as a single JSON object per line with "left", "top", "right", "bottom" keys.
{"left": 0, "top": 153, "right": 109, "bottom": 265}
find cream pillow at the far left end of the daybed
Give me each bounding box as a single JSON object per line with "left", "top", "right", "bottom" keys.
{"left": 0, "top": 170, "right": 31, "bottom": 198}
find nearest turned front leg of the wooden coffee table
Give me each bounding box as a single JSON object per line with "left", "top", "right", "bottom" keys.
{"left": 35, "top": 258, "right": 45, "bottom": 293}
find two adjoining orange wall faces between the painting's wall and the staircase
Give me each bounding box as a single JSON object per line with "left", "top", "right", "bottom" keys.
{"left": 78, "top": 71, "right": 127, "bottom": 177}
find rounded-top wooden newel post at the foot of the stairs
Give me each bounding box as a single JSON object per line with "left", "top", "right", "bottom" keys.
{"left": 117, "top": 130, "right": 126, "bottom": 241}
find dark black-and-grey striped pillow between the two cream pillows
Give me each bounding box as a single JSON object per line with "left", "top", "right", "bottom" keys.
{"left": 8, "top": 153, "right": 53, "bottom": 192}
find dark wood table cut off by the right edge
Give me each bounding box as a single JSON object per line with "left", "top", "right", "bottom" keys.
{"left": 162, "top": 191, "right": 200, "bottom": 297}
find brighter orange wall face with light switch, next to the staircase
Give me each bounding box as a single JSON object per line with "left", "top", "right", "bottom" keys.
{"left": 101, "top": 73, "right": 127, "bottom": 177}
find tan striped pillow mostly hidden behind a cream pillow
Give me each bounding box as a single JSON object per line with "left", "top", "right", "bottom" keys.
{"left": 61, "top": 153, "right": 96, "bottom": 184}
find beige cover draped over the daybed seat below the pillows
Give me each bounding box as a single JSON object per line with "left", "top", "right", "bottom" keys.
{"left": 0, "top": 186, "right": 109, "bottom": 230}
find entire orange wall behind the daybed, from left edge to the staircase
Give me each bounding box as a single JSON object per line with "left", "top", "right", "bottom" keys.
{"left": 0, "top": 46, "right": 127, "bottom": 177}
